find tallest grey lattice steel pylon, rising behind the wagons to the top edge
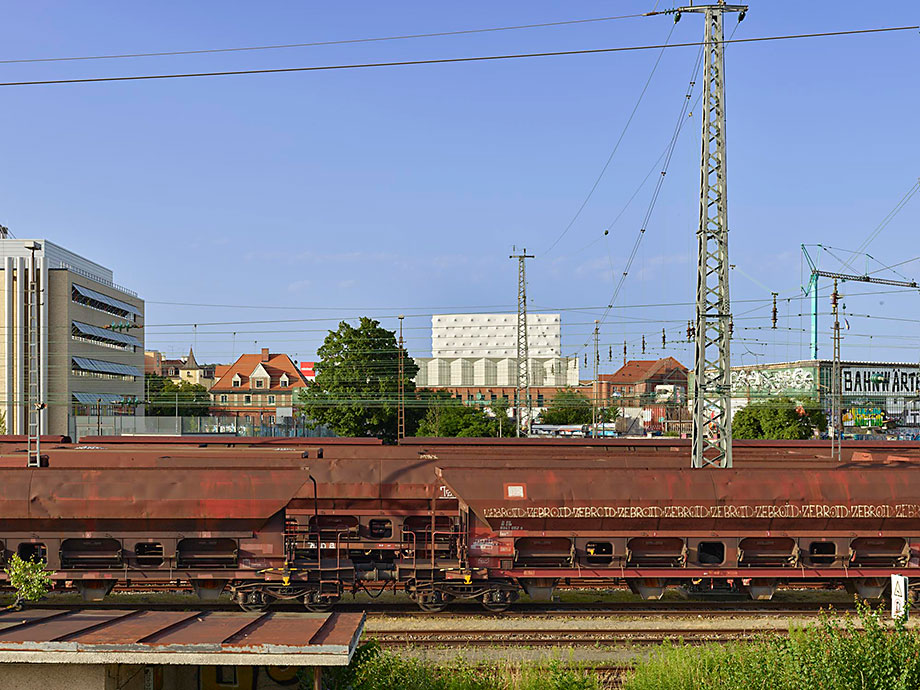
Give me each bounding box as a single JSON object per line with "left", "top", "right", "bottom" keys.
{"left": 675, "top": 3, "right": 747, "bottom": 467}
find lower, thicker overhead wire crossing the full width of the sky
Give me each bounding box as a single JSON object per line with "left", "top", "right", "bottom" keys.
{"left": 0, "top": 25, "right": 908, "bottom": 86}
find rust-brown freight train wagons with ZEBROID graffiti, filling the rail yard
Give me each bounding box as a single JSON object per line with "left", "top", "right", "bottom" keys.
{"left": 0, "top": 439, "right": 920, "bottom": 611}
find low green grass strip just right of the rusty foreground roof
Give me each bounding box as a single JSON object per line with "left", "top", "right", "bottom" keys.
{"left": 310, "top": 642, "right": 602, "bottom": 690}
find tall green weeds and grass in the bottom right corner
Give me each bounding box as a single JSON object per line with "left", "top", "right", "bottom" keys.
{"left": 624, "top": 605, "right": 920, "bottom": 690}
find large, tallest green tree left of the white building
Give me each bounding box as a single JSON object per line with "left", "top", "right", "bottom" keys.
{"left": 300, "top": 316, "right": 421, "bottom": 440}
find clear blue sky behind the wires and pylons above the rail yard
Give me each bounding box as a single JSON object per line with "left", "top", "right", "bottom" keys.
{"left": 0, "top": 0, "right": 920, "bottom": 370}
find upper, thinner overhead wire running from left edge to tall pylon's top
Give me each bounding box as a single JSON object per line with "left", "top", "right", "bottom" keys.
{"left": 0, "top": 13, "right": 648, "bottom": 65}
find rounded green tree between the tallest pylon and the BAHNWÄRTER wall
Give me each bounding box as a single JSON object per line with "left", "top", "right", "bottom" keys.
{"left": 732, "top": 397, "right": 827, "bottom": 440}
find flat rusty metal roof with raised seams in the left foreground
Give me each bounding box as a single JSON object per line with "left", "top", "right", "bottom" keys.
{"left": 0, "top": 609, "right": 365, "bottom": 666}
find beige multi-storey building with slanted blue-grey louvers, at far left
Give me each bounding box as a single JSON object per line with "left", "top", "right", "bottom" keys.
{"left": 0, "top": 237, "right": 144, "bottom": 435}
